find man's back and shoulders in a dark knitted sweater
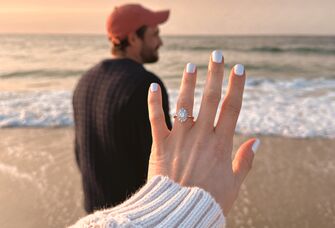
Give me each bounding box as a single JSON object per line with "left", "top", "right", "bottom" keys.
{"left": 73, "top": 59, "right": 171, "bottom": 212}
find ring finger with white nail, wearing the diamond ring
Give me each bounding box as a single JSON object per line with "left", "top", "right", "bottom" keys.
{"left": 174, "top": 63, "right": 197, "bottom": 129}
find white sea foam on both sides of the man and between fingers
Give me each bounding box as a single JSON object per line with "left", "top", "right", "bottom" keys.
{"left": 0, "top": 78, "right": 335, "bottom": 138}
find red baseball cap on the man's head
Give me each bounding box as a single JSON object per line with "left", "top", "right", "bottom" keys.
{"left": 106, "top": 4, "right": 170, "bottom": 44}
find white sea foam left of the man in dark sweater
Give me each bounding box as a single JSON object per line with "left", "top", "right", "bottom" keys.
{"left": 0, "top": 91, "right": 73, "bottom": 127}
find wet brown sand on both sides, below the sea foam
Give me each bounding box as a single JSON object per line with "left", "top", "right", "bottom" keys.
{"left": 0, "top": 128, "right": 335, "bottom": 228}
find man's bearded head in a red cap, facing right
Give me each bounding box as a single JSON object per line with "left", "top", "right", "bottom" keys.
{"left": 106, "top": 4, "right": 169, "bottom": 63}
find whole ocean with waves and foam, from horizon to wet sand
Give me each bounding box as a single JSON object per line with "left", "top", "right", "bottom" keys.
{"left": 0, "top": 35, "right": 335, "bottom": 138}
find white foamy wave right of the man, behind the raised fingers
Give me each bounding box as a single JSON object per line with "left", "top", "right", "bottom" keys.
{"left": 170, "top": 78, "right": 335, "bottom": 138}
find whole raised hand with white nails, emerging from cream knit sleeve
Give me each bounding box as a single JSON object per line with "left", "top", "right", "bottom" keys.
{"left": 148, "top": 51, "right": 259, "bottom": 215}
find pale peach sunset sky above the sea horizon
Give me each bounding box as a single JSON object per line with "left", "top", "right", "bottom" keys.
{"left": 0, "top": 0, "right": 335, "bottom": 35}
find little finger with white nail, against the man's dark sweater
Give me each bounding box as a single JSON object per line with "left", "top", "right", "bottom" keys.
{"left": 148, "top": 83, "right": 170, "bottom": 143}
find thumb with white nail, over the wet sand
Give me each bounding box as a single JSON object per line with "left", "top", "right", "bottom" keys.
{"left": 233, "top": 138, "right": 260, "bottom": 186}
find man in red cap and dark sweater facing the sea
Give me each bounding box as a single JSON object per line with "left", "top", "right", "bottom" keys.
{"left": 73, "top": 4, "right": 171, "bottom": 213}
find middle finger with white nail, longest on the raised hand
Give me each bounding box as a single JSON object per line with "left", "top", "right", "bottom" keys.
{"left": 197, "top": 50, "right": 224, "bottom": 129}
